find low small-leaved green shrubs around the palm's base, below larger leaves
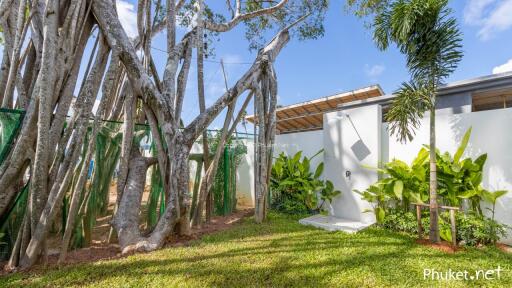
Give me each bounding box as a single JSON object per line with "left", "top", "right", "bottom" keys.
{"left": 379, "top": 209, "right": 507, "bottom": 246}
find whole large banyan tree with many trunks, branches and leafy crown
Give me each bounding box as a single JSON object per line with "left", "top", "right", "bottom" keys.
{"left": 0, "top": 0, "right": 328, "bottom": 269}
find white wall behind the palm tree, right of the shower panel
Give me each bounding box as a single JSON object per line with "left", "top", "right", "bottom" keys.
{"left": 382, "top": 108, "right": 512, "bottom": 244}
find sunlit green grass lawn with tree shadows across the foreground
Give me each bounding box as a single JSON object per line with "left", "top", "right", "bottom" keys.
{"left": 0, "top": 214, "right": 512, "bottom": 287}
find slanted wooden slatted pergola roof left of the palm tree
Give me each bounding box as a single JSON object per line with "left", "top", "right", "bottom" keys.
{"left": 245, "top": 85, "right": 384, "bottom": 134}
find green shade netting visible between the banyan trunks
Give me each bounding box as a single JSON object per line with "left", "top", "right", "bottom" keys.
{"left": 0, "top": 109, "right": 246, "bottom": 259}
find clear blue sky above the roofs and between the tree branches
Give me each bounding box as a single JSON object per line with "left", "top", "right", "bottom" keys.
{"left": 118, "top": 0, "right": 512, "bottom": 127}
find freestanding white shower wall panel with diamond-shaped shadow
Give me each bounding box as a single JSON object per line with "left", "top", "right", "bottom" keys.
{"left": 323, "top": 105, "right": 381, "bottom": 223}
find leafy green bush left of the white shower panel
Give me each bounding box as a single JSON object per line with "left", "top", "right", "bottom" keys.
{"left": 270, "top": 150, "right": 341, "bottom": 214}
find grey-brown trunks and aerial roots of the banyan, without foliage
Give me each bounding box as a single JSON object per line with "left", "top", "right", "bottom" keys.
{"left": 0, "top": 0, "right": 304, "bottom": 268}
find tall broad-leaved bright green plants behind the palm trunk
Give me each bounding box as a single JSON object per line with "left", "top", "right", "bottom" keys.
{"left": 355, "top": 128, "right": 506, "bottom": 222}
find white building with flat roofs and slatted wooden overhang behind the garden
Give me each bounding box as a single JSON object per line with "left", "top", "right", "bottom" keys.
{"left": 248, "top": 73, "right": 512, "bottom": 244}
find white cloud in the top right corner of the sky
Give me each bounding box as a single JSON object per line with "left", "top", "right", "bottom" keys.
{"left": 464, "top": 0, "right": 512, "bottom": 40}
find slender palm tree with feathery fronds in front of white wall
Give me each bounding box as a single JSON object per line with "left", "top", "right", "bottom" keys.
{"left": 372, "top": 0, "right": 462, "bottom": 242}
